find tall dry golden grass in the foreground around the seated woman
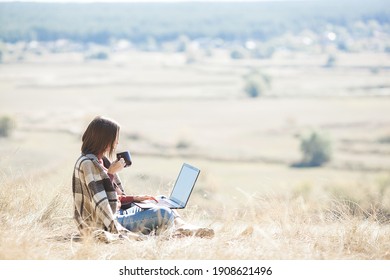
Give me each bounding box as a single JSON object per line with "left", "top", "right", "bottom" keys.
{"left": 0, "top": 165, "right": 390, "bottom": 260}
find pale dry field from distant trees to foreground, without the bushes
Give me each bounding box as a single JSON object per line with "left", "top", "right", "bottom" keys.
{"left": 0, "top": 50, "right": 390, "bottom": 259}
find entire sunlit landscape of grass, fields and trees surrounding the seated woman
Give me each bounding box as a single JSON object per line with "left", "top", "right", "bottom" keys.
{"left": 0, "top": 0, "right": 390, "bottom": 259}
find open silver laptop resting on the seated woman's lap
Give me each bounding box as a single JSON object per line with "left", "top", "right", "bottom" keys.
{"left": 134, "top": 163, "right": 200, "bottom": 209}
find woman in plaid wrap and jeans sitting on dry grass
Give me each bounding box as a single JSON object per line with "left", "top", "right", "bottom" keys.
{"left": 72, "top": 117, "right": 214, "bottom": 240}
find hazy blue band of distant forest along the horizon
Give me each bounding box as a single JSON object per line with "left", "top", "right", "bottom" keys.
{"left": 0, "top": 0, "right": 390, "bottom": 45}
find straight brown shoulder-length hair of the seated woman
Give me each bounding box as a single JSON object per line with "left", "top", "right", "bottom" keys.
{"left": 81, "top": 116, "right": 120, "bottom": 157}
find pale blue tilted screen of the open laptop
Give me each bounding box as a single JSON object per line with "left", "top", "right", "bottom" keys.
{"left": 170, "top": 163, "right": 200, "bottom": 206}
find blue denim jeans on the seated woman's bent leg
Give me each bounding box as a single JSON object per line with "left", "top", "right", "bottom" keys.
{"left": 117, "top": 206, "right": 174, "bottom": 234}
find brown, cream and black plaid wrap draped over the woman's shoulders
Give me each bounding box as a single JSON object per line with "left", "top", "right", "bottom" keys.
{"left": 72, "top": 154, "right": 123, "bottom": 234}
